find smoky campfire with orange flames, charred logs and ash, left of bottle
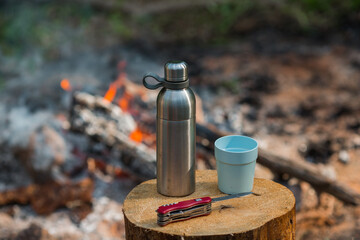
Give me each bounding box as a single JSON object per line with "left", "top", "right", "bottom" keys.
{"left": 0, "top": 61, "right": 156, "bottom": 237}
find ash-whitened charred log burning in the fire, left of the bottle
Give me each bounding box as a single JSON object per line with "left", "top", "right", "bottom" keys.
{"left": 71, "top": 92, "right": 156, "bottom": 180}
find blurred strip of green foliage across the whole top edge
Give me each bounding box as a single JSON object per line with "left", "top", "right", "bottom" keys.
{"left": 0, "top": 0, "right": 360, "bottom": 49}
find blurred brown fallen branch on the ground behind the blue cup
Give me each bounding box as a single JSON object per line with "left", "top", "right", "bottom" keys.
{"left": 196, "top": 124, "right": 360, "bottom": 205}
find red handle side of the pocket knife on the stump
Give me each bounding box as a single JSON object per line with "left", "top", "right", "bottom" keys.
{"left": 156, "top": 197, "right": 211, "bottom": 214}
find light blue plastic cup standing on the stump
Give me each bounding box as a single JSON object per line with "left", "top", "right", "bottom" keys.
{"left": 215, "top": 135, "right": 258, "bottom": 194}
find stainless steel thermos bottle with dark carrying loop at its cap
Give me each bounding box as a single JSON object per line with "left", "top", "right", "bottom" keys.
{"left": 143, "top": 61, "right": 196, "bottom": 197}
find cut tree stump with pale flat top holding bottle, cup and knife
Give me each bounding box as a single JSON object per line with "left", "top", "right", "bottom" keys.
{"left": 123, "top": 170, "right": 295, "bottom": 240}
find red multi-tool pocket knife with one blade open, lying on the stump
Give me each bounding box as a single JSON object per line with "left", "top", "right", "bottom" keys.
{"left": 156, "top": 192, "right": 258, "bottom": 226}
